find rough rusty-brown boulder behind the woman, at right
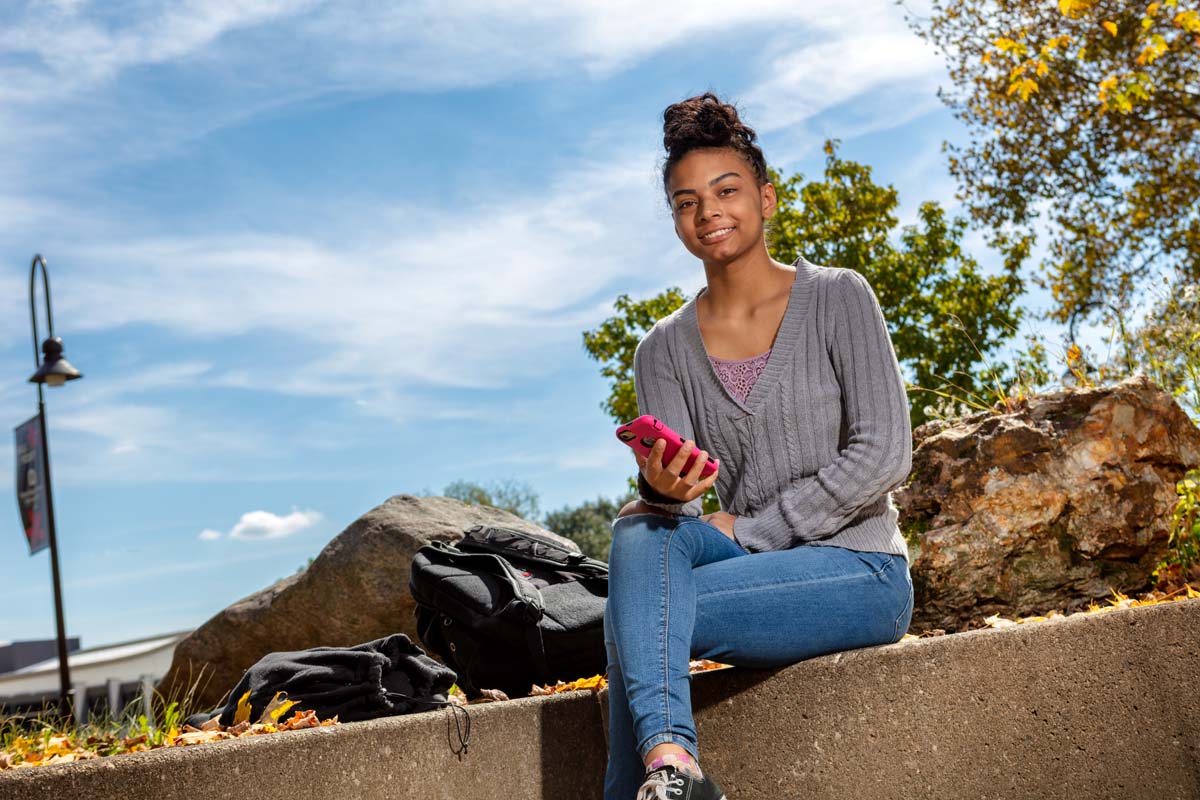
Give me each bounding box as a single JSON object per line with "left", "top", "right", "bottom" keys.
{"left": 894, "top": 375, "right": 1200, "bottom": 633}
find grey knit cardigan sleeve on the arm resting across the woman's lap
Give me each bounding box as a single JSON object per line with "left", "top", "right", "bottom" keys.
{"left": 733, "top": 269, "right": 912, "bottom": 552}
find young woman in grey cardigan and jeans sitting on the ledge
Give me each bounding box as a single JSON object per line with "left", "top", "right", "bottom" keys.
{"left": 605, "top": 94, "right": 912, "bottom": 800}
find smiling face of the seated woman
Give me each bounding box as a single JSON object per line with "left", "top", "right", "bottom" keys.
{"left": 667, "top": 148, "right": 775, "bottom": 264}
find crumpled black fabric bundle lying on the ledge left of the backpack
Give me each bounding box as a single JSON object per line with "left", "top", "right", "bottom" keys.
{"left": 187, "top": 633, "right": 456, "bottom": 727}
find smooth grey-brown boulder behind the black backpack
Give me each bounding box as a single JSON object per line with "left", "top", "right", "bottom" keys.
{"left": 158, "top": 494, "right": 576, "bottom": 708}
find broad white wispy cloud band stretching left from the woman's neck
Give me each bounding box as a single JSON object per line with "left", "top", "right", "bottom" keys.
{"left": 18, "top": 149, "right": 695, "bottom": 400}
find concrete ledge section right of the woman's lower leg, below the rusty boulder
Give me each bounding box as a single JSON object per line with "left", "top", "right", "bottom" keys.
{"left": 692, "top": 600, "right": 1200, "bottom": 800}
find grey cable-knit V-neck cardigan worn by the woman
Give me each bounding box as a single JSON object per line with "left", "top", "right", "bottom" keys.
{"left": 634, "top": 258, "right": 912, "bottom": 559}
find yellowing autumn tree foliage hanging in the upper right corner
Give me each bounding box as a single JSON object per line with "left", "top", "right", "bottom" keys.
{"left": 910, "top": 0, "right": 1200, "bottom": 335}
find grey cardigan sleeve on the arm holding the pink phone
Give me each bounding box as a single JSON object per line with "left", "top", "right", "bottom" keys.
{"left": 634, "top": 329, "right": 703, "bottom": 517}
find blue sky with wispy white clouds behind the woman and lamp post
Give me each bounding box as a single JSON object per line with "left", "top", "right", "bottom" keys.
{"left": 0, "top": 0, "right": 1123, "bottom": 646}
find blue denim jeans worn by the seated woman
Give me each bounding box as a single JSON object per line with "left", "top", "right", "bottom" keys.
{"left": 604, "top": 513, "right": 912, "bottom": 800}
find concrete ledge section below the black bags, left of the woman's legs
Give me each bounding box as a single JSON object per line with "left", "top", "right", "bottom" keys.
{"left": 0, "top": 692, "right": 605, "bottom": 800}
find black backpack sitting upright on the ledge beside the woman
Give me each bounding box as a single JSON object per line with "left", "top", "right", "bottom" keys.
{"left": 408, "top": 525, "right": 608, "bottom": 698}
